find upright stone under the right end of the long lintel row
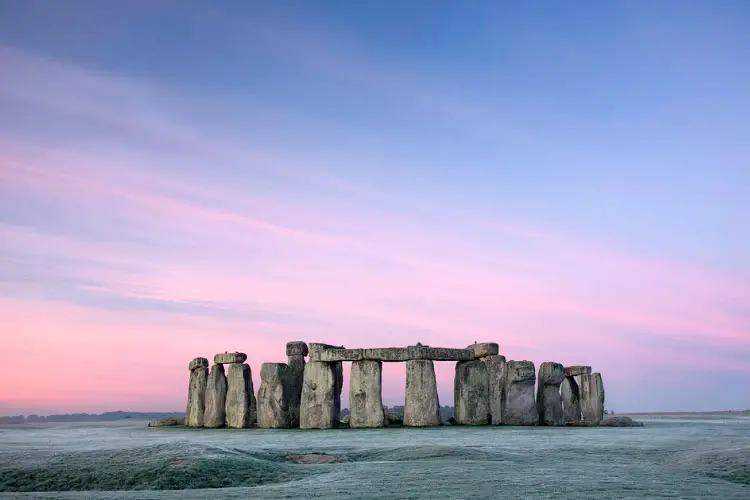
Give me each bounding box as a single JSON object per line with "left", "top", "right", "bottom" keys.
{"left": 453, "top": 359, "right": 490, "bottom": 425}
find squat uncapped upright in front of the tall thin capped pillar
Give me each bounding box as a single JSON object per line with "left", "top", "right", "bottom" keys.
{"left": 258, "top": 363, "right": 290, "bottom": 429}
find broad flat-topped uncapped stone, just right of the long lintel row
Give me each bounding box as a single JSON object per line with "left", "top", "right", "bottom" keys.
{"left": 503, "top": 361, "right": 539, "bottom": 425}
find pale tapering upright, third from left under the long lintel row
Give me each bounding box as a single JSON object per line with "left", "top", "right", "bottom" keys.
{"left": 404, "top": 360, "right": 440, "bottom": 427}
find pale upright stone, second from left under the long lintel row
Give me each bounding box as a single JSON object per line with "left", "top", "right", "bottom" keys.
{"left": 349, "top": 360, "right": 385, "bottom": 427}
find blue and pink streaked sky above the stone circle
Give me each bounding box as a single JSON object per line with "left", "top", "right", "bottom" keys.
{"left": 0, "top": 0, "right": 750, "bottom": 414}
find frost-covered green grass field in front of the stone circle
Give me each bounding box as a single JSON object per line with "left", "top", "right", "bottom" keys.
{"left": 0, "top": 417, "right": 750, "bottom": 500}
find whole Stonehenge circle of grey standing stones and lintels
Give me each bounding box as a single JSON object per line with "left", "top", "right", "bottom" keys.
{"left": 184, "top": 341, "right": 605, "bottom": 429}
